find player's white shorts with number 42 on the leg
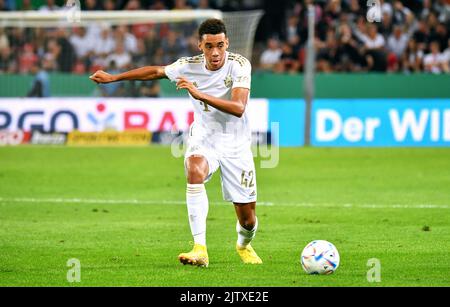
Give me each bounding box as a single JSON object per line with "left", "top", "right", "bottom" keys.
{"left": 184, "top": 134, "right": 257, "bottom": 204}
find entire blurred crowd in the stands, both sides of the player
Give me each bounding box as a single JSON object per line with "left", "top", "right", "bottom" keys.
{"left": 0, "top": 0, "right": 450, "bottom": 79}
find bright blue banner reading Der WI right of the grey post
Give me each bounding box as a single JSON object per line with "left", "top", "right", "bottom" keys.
{"left": 312, "top": 99, "right": 450, "bottom": 146}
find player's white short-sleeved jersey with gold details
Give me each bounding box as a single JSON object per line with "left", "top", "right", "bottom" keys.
{"left": 165, "top": 52, "right": 251, "bottom": 156}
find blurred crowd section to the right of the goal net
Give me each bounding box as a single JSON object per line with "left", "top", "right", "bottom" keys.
{"left": 260, "top": 0, "right": 450, "bottom": 73}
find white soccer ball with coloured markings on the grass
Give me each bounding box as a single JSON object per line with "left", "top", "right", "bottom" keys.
{"left": 300, "top": 240, "right": 340, "bottom": 275}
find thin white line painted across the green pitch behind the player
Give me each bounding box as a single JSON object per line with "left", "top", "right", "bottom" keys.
{"left": 0, "top": 197, "right": 450, "bottom": 209}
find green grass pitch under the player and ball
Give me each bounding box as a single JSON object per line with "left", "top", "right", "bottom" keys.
{"left": 0, "top": 146, "right": 450, "bottom": 287}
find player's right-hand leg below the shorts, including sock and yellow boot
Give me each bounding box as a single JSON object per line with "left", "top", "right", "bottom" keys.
{"left": 234, "top": 202, "right": 262, "bottom": 264}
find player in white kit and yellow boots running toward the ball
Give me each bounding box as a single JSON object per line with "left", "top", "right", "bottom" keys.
{"left": 90, "top": 19, "right": 262, "bottom": 267}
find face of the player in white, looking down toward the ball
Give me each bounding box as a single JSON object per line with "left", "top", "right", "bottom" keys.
{"left": 198, "top": 33, "right": 228, "bottom": 70}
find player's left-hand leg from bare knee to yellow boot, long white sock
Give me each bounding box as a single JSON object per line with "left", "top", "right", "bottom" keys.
{"left": 178, "top": 155, "right": 209, "bottom": 267}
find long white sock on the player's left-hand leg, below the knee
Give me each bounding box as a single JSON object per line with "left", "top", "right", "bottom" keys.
{"left": 186, "top": 183, "right": 208, "bottom": 246}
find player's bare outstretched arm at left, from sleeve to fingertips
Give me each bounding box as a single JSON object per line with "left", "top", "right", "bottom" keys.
{"left": 89, "top": 66, "right": 167, "bottom": 83}
